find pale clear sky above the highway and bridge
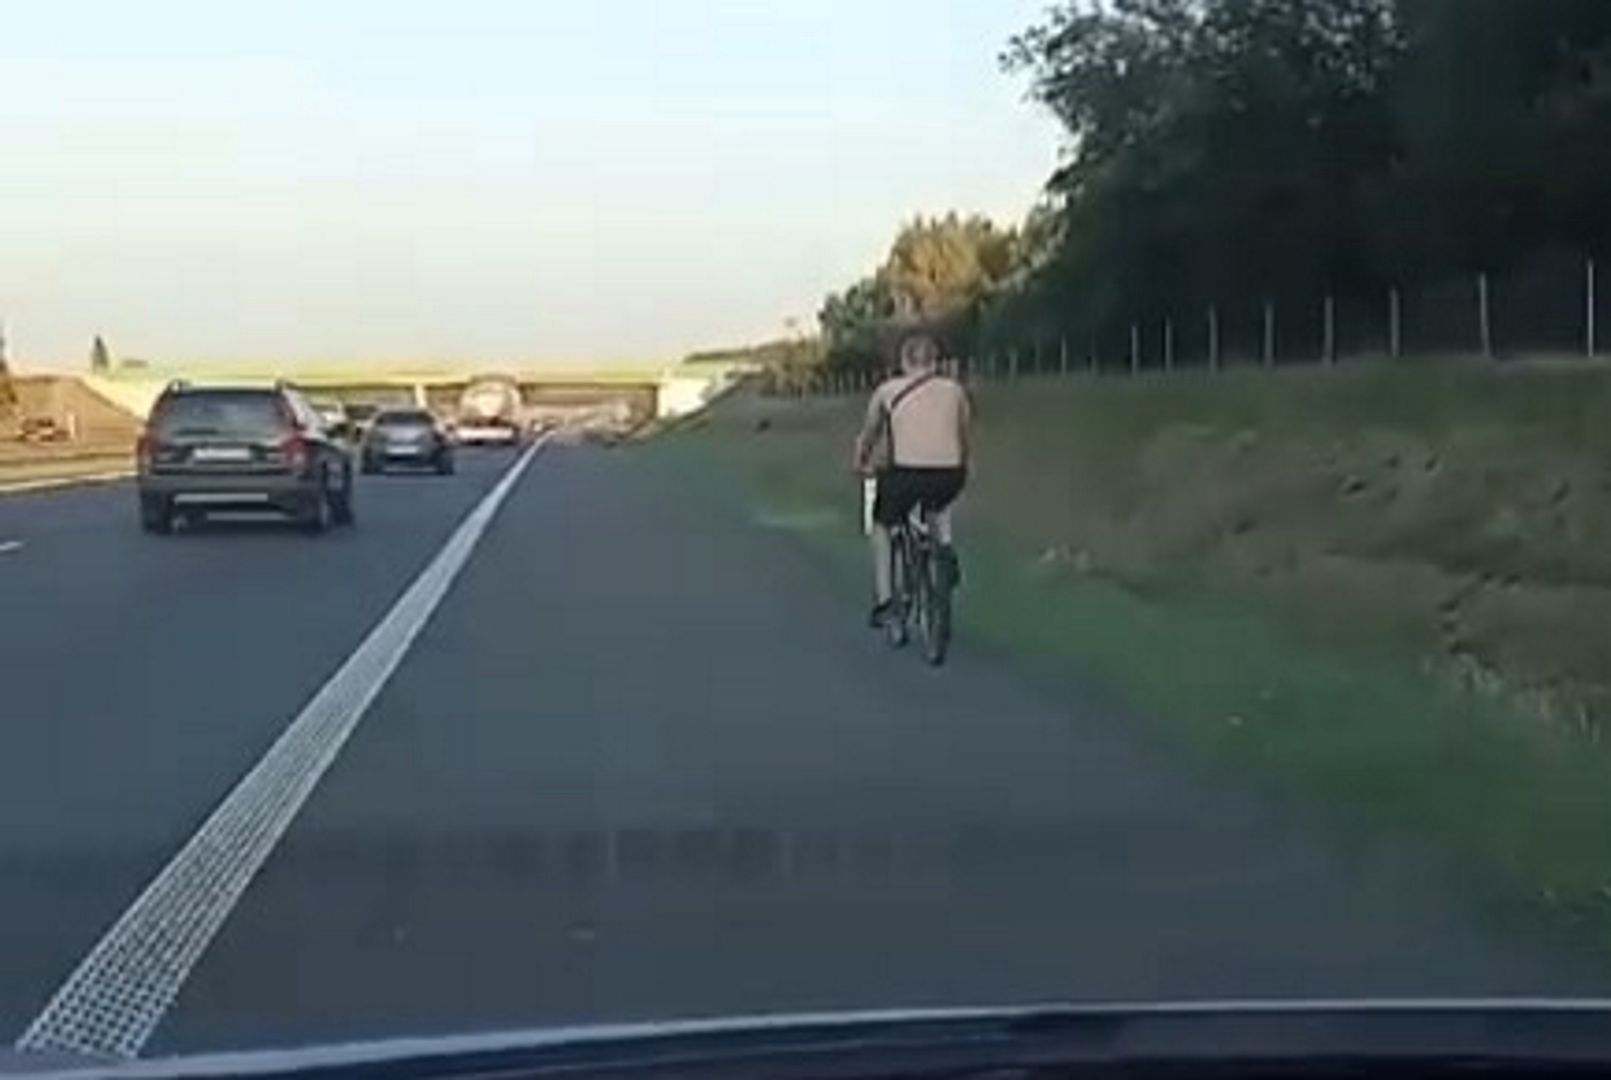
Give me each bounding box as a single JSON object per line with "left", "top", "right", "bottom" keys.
{"left": 0, "top": 0, "right": 1057, "bottom": 368}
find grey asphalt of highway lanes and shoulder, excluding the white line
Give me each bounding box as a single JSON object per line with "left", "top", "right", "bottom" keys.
{"left": 0, "top": 448, "right": 1605, "bottom": 1056}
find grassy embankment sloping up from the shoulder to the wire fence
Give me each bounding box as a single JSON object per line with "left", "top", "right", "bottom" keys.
{"left": 662, "top": 368, "right": 1611, "bottom": 948}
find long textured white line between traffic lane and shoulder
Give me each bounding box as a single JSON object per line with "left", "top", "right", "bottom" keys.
{"left": 16, "top": 440, "right": 543, "bottom": 1057}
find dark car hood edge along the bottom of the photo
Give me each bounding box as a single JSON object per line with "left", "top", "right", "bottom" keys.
{"left": 15, "top": 999, "right": 1611, "bottom": 1080}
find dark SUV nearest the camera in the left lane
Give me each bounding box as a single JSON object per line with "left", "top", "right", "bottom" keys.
{"left": 137, "top": 384, "right": 353, "bottom": 532}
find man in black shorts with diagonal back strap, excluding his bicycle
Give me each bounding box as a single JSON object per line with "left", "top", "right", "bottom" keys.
{"left": 854, "top": 334, "right": 971, "bottom": 627}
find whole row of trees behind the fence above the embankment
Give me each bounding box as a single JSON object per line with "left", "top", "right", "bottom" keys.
{"left": 796, "top": 0, "right": 1611, "bottom": 377}
